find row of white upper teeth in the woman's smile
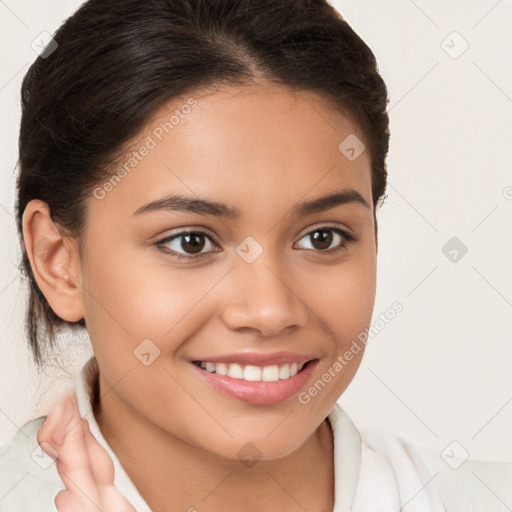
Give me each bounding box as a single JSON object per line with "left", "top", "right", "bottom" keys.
{"left": 199, "top": 361, "right": 304, "bottom": 382}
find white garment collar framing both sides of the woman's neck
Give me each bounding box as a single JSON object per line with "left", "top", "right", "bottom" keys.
{"left": 75, "top": 356, "right": 361, "bottom": 512}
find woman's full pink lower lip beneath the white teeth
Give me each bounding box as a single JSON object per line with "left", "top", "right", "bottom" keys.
{"left": 191, "top": 359, "right": 318, "bottom": 405}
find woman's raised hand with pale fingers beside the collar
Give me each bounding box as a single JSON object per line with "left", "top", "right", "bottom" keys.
{"left": 37, "top": 391, "right": 137, "bottom": 512}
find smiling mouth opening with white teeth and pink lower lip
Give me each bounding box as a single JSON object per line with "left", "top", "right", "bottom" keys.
{"left": 191, "top": 359, "right": 319, "bottom": 405}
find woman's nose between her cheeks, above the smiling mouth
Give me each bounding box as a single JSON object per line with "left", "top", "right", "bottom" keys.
{"left": 222, "top": 252, "right": 309, "bottom": 337}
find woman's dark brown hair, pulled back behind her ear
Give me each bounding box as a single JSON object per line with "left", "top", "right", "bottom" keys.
{"left": 16, "top": 0, "right": 389, "bottom": 365}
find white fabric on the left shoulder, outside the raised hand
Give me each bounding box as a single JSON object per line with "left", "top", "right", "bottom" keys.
{"left": 0, "top": 416, "right": 64, "bottom": 512}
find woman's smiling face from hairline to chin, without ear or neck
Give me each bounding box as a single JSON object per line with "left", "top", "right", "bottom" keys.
{"left": 80, "top": 83, "right": 376, "bottom": 459}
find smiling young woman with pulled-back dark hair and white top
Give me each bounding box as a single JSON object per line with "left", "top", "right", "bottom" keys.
{"left": 0, "top": 0, "right": 512, "bottom": 512}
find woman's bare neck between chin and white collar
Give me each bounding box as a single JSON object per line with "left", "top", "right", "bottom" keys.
{"left": 95, "top": 375, "right": 334, "bottom": 512}
